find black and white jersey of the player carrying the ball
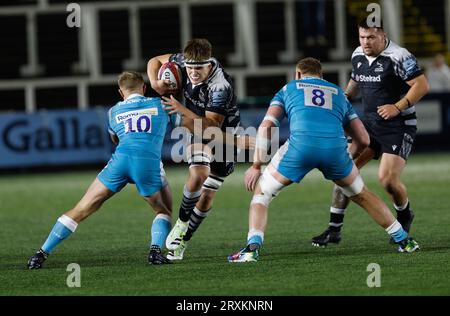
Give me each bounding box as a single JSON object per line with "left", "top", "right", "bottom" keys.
{"left": 169, "top": 53, "right": 240, "bottom": 131}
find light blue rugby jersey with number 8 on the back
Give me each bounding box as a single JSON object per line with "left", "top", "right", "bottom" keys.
{"left": 270, "top": 78, "right": 358, "bottom": 146}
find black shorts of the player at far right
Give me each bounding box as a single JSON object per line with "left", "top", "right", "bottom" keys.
{"left": 363, "top": 120, "right": 417, "bottom": 160}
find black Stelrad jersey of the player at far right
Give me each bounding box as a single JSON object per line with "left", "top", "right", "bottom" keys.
{"left": 351, "top": 40, "right": 423, "bottom": 125}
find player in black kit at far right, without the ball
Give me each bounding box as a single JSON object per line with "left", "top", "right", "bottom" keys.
{"left": 312, "top": 20, "right": 429, "bottom": 246}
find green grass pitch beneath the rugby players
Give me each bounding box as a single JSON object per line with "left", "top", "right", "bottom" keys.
{"left": 0, "top": 154, "right": 450, "bottom": 296}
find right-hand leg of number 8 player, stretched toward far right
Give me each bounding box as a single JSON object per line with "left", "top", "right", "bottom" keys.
{"left": 335, "top": 166, "right": 419, "bottom": 252}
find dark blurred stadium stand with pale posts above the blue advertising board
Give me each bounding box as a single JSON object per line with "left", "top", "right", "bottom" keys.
{"left": 0, "top": 0, "right": 450, "bottom": 169}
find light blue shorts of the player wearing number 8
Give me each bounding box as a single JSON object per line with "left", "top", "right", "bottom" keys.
{"left": 271, "top": 141, "right": 353, "bottom": 183}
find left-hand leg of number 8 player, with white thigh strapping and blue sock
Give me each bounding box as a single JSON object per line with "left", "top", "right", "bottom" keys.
{"left": 228, "top": 164, "right": 292, "bottom": 262}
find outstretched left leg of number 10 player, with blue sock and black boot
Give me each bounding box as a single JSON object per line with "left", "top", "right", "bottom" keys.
{"left": 28, "top": 178, "right": 114, "bottom": 269}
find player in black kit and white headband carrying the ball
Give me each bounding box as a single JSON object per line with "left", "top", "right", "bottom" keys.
{"left": 147, "top": 39, "right": 240, "bottom": 260}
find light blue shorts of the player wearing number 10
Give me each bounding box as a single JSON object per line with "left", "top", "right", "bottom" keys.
{"left": 97, "top": 153, "right": 167, "bottom": 196}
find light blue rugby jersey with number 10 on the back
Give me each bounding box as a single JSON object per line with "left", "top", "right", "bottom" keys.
{"left": 108, "top": 94, "right": 169, "bottom": 160}
